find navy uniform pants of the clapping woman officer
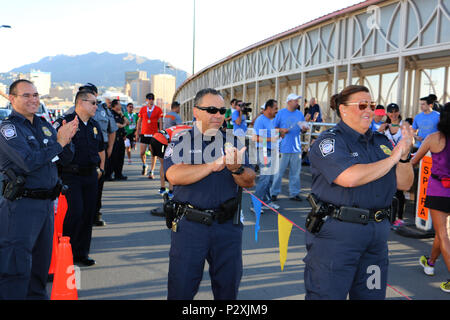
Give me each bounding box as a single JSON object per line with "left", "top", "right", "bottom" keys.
{"left": 303, "top": 219, "right": 390, "bottom": 300}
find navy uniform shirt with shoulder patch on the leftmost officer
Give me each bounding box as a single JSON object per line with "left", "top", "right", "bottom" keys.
{"left": 0, "top": 110, "right": 73, "bottom": 189}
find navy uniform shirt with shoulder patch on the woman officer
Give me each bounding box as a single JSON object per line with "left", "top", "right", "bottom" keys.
{"left": 309, "top": 121, "right": 397, "bottom": 209}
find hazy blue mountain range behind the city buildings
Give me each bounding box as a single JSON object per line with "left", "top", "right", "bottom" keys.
{"left": 3, "top": 52, "right": 187, "bottom": 87}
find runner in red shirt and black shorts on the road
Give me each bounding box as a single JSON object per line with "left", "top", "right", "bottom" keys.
{"left": 136, "top": 93, "right": 163, "bottom": 180}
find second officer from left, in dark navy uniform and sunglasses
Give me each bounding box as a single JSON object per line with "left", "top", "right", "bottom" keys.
{"left": 54, "top": 90, "right": 105, "bottom": 266}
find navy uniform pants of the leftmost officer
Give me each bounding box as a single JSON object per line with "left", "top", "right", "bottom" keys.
{"left": 0, "top": 198, "right": 54, "bottom": 300}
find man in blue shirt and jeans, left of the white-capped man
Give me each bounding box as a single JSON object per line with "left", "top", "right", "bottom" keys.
{"left": 252, "top": 99, "right": 279, "bottom": 209}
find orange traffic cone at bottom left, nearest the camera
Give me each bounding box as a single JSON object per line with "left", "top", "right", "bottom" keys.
{"left": 50, "top": 237, "right": 78, "bottom": 300}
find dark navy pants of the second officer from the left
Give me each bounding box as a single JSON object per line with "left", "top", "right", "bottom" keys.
{"left": 62, "top": 171, "right": 98, "bottom": 258}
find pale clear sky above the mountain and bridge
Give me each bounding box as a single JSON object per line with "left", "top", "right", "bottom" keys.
{"left": 0, "top": 0, "right": 361, "bottom": 73}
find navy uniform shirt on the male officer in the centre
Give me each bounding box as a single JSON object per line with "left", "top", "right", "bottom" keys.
{"left": 164, "top": 126, "right": 253, "bottom": 210}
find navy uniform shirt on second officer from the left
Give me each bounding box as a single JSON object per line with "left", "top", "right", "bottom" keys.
{"left": 54, "top": 112, "right": 105, "bottom": 167}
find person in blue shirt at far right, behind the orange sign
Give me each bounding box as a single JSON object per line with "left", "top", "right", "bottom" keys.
{"left": 413, "top": 97, "right": 440, "bottom": 148}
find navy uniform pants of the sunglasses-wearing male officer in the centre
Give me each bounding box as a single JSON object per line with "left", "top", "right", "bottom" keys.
{"left": 167, "top": 217, "right": 243, "bottom": 300}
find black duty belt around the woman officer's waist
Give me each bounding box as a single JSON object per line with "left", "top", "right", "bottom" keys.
{"left": 328, "top": 206, "right": 391, "bottom": 224}
